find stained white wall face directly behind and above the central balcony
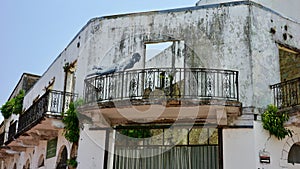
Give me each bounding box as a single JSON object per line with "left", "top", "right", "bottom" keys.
{"left": 76, "top": 5, "right": 252, "bottom": 106}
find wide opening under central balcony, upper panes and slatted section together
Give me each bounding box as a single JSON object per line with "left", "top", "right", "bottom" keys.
{"left": 113, "top": 126, "right": 221, "bottom": 169}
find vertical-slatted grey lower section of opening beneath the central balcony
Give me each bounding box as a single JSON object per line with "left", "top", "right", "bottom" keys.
{"left": 113, "top": 145, "right": 219, "bottom": 169}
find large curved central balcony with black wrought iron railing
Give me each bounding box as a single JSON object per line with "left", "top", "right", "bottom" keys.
{"left": 83, "top": 68, "right": 241, "bottom": 124}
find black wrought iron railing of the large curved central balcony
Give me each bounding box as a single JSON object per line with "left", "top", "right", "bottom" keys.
{"left": 84, "top": 68, "right": 239, "bottom": 103}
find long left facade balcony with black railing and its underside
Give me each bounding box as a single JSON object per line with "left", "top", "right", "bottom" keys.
{"left": 3, "top": 90, "right": 77, "bottom": 146}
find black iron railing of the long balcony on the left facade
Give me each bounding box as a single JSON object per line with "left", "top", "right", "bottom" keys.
{"left": 18, "top": 90, "right": 77, "bottom": 134}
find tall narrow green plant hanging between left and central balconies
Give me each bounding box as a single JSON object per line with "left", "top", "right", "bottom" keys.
{"left": 62, "top": 102, "right": 79, "bottom": 143}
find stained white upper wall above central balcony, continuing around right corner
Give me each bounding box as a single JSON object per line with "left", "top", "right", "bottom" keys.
{"left": 77, "top": 1, "right": 299, "bottom": 111}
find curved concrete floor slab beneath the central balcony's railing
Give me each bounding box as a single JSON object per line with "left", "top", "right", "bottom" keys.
{"left": 79, "top": 100, "right": 241, "bottom": 127}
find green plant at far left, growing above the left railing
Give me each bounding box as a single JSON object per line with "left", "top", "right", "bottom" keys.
{"left": 0, "top": 90, "right": 25, "bottom": 119}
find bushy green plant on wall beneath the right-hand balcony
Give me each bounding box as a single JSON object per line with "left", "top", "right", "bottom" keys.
{"left": 261, "top": 105, "right": 292, "bottom": 140}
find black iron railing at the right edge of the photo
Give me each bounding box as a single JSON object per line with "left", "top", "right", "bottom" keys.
{"left": 270, "top": 77, "right": 300, "bottom": 109}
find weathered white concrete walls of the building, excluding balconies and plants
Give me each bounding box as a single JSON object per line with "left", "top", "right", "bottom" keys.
{"left": 2, "top": 0, "right": 300, "bottom": 169}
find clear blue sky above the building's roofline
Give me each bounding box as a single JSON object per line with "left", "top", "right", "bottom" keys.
{"left": 0, "top": 0, "right": 197, "bottom": 121}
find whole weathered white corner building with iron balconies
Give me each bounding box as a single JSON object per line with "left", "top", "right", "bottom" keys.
{"left": 1, "top": 1, "right": 300, "bottom": 169}
